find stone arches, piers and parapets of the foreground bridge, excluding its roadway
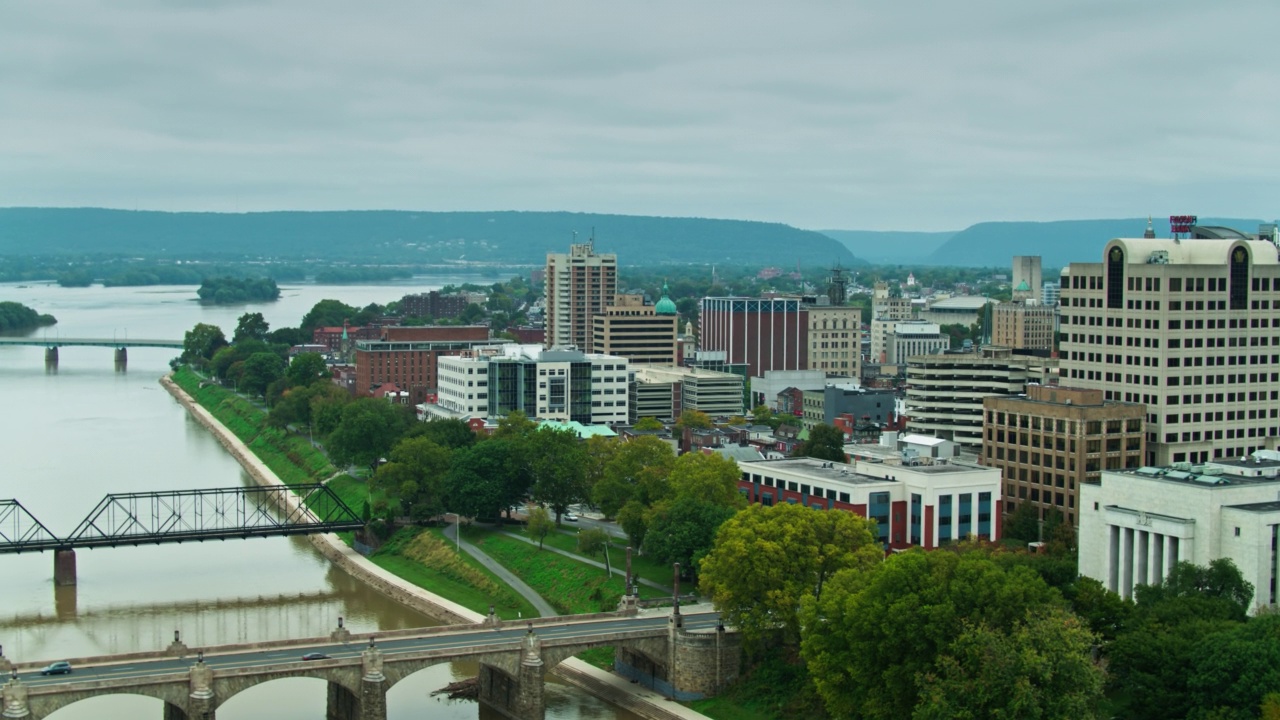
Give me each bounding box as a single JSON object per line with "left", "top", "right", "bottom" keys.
{"left": 0, "top": 604, "right": 740, "bottom": 720}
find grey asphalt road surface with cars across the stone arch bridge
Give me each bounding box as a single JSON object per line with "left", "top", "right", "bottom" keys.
{"left": 19, "top": 612, "right": 719, "bottom": 688}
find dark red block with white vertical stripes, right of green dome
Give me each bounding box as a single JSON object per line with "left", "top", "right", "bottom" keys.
{"left": 698, "top": 297, "right": 809, "bottom": 378}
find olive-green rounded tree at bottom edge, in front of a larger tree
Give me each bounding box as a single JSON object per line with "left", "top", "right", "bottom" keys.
{"left": 913, "top": 607, "right": 1102, "bottom": 720}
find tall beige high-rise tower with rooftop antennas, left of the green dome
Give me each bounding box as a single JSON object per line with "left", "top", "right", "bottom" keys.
{"left": 547, "top": 242, "right": 618, "bottom": 350}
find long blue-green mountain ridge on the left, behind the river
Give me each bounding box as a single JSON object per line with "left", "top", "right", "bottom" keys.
{"left": 0, "top": 208, "right": 865, "bottom": 266}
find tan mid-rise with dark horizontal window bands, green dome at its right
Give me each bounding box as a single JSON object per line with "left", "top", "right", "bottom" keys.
{"left": 588, "top": 284, "right": 680, "bottom": 366}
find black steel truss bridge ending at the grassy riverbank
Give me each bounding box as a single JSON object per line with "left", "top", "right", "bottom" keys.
{"left": 0, "top": 483, "right": 365, "bottom": 585}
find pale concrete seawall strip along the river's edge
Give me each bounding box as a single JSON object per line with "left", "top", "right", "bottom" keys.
{"left": 160, "top": 375, "right": 708, "bottom": 720}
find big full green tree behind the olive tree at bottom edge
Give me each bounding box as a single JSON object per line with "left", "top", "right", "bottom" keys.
{"left": 801, "top": 547, "right": 1062, "bottom": 720}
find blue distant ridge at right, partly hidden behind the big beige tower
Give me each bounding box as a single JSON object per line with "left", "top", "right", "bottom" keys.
{"left": 925, "top": 218, "right": 1274, "bottom": 268}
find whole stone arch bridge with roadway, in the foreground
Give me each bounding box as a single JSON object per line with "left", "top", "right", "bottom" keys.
{"left": 0, "top": 611, "right": 739, "bottom": 720}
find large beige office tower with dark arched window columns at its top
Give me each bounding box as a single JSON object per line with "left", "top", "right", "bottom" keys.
{"left": 1061, "top": 227, "right": 1280, "bottom": 465}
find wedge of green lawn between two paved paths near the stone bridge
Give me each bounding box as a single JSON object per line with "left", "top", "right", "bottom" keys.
{"left": 462, "top": 527, "right": 660, "bottom": 615}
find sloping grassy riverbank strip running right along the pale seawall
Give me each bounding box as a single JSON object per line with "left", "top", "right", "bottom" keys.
{"left": 173, "top": 368, "right": 538, "bottom": 619}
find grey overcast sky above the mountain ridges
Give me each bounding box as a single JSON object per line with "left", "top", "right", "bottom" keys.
{"left": 0, "top": 0, "right": 1280, "bottom": 229}
